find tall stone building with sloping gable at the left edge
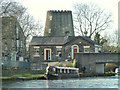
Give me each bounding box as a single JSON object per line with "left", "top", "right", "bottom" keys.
{"left": 2, "top": 17, "right": 26, "bottom": 61}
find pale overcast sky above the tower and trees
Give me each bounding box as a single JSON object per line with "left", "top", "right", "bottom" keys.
{"left": 16, "top": 0, "right": 119, "bottom": 35}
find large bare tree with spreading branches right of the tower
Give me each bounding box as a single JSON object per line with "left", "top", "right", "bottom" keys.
{"left": 74, "top": 3, "right": 112, "bottom": 38}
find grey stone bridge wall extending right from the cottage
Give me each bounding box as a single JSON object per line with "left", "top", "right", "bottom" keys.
{"left": 75, "top": 53, "right": 120, "bottom": 73}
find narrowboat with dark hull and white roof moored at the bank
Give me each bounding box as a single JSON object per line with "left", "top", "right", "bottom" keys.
{"left": 44, "top": 66, "right": 79, "bottom": 80}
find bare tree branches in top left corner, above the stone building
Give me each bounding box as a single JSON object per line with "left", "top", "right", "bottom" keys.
{"left": 0, "top": 1, "right": 26, "bottom": 17}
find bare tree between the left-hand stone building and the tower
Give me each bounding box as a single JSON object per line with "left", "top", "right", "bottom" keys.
{"left": 19, "top": 13, "right": 43, "bottom": 42}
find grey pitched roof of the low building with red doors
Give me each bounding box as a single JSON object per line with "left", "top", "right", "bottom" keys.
{"left": 30, "top": 36, "right": 99, "bottom": 45}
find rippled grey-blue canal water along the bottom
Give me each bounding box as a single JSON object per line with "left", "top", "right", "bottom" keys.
{"left": 2, "top": 77, "right": 119, "bottom": 88}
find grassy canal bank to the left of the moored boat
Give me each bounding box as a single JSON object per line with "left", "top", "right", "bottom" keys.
{"left": 0, "top": 69, "right": 45, "bottom": 80}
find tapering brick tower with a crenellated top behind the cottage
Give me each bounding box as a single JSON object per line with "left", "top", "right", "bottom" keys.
{"left": 44, "top": 10, "right": 74, "bottom": 36}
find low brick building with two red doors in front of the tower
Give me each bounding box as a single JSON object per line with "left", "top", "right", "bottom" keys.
{"left": 30, "top": 36, "right": 101, "bottom": 62}
